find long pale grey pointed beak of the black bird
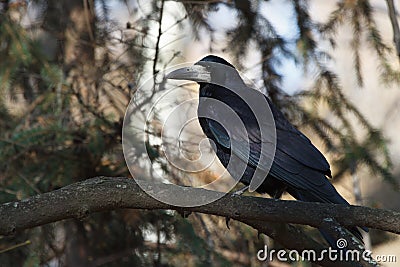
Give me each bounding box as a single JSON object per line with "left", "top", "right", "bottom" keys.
{"left": 166, "top": 65, "right": 211, "bottom": 82}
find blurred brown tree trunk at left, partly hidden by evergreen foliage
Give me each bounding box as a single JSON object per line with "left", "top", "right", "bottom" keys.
{"left": 44, "top": 0, "right": 96, "bottom": 267}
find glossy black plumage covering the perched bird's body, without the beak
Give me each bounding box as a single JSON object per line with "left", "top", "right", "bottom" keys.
{"left": 195, "top": 55, "right": 368, "bottom": 245}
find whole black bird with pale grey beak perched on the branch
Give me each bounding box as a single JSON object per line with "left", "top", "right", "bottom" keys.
{"left": 167, "top": 55, "right": 362, "bottom": 245}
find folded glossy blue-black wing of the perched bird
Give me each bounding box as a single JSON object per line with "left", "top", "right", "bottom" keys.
{"left": 203, "top": 93, "right": 340, "bottom": 203}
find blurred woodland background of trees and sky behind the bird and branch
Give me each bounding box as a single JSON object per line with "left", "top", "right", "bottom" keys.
{"left": 0, "top": 0, "right": 400, "bottom": 266}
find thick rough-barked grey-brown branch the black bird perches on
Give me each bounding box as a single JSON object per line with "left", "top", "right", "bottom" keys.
{"left": 0, "top": 177, "right": 400, "bottom": 266}
